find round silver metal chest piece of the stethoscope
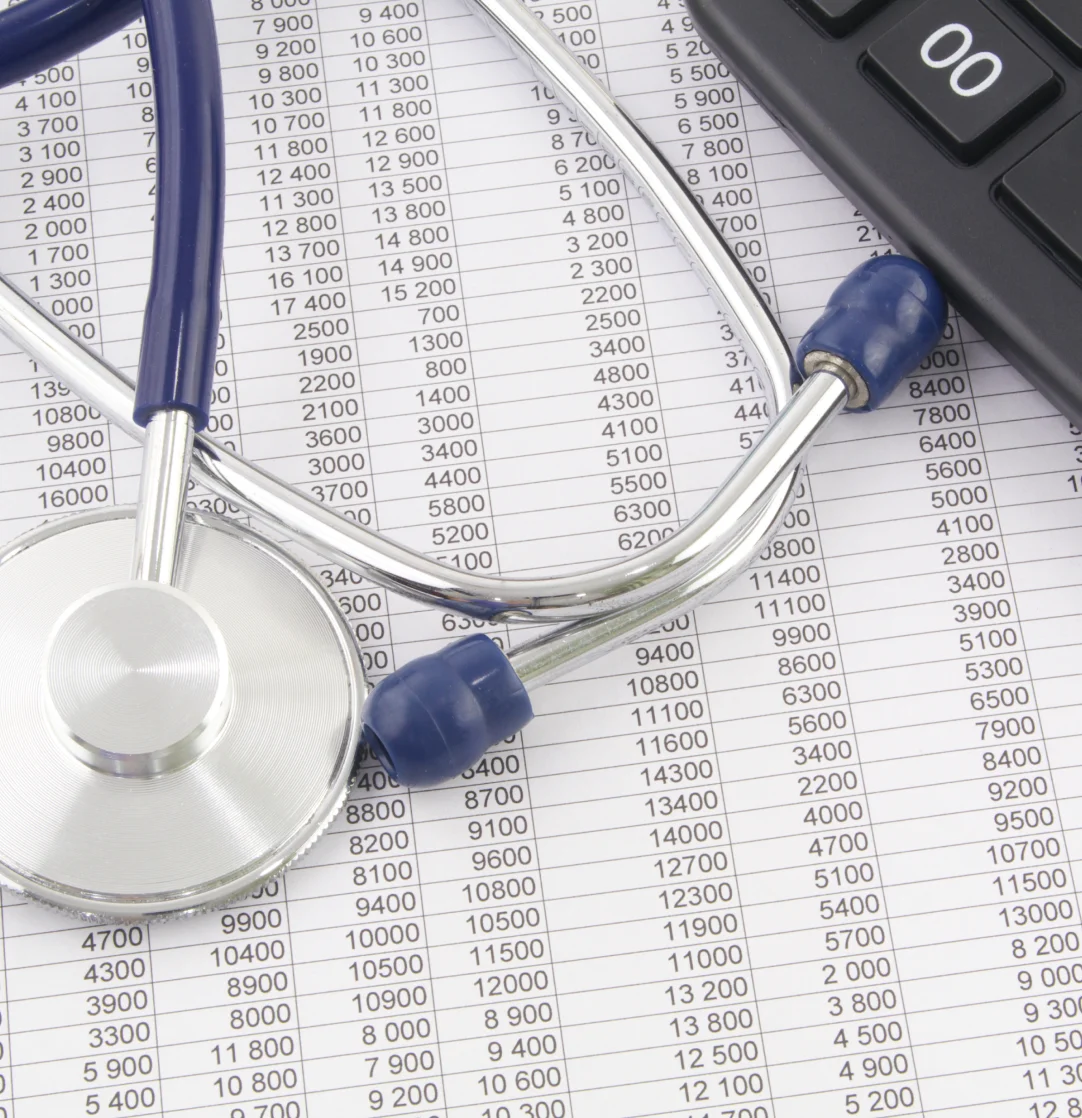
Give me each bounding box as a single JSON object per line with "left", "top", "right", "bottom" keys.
{"left": 0, "top": 511, "right": 367, "bottom": 920}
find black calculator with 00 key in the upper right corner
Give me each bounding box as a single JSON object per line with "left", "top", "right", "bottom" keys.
{"left": 686, "top": 0, "right": 1082, "bottom": 424}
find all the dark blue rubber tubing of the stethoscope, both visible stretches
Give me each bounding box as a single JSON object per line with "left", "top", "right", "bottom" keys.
{"left": 0, "top": 0, "right": 226, "bottom": 430}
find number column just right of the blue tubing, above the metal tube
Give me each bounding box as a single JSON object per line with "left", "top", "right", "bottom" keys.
{"left": 219, "top": 0, "right": 372, "bottom": 532}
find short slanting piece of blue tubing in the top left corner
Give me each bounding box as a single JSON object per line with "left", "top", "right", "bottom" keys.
{"left": 0, "top": 0, "right": 143, "bottom": 87}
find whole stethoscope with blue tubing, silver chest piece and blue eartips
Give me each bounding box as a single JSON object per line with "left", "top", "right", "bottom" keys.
{"left": 0, "top": 0, "right": 947, "bottom": 920}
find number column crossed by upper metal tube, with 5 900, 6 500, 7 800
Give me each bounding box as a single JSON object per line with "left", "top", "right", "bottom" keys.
{"left": 604, "top": 3, "right": 773, "bottom": 545}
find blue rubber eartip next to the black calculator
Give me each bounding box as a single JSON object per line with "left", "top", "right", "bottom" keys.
{"left": 796, "top": 254, "right": 947, "bottom": 411}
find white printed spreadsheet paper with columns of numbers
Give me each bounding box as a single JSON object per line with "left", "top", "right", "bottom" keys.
{"left": 0, "top": 0, "right": 1082, "bottom": 1118}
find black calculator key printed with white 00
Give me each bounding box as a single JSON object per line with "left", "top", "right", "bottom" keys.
{"left": 866, "top": 0, "right": 1059, "bottom": 163}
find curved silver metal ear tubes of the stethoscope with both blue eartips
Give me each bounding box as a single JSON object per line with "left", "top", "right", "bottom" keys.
{"left": 0, "top": 0, "right": 946, "bottom": 813}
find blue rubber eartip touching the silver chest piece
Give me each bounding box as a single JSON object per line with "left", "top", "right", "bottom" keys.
{"left": 361, "top": 633, "right": 533, "bottom": 788}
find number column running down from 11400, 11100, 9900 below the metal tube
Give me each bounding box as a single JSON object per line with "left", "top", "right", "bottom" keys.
{"left": 703, "top": 474, "right": 918, "bottom": 1114}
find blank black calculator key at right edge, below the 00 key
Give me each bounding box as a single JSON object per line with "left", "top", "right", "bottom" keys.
{"left": 999, "top": 116, "right": 1082, "bottom": 267}
